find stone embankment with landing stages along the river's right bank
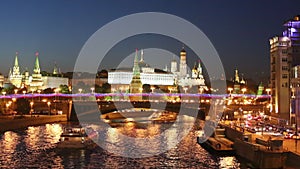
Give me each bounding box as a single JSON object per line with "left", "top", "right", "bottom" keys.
{"left": 216, "top": 124, "right": 300, "bottom": 168}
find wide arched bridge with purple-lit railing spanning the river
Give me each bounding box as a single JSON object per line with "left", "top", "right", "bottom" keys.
{"left": 0, "top": 93, "right": 270, "bottom": 119}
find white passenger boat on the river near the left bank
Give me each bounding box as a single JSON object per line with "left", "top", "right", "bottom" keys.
{"left": 57, "top": 127, "right": 93, "bottom": 148}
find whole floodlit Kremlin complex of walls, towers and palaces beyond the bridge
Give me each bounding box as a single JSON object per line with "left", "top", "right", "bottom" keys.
{"left": 0, "top": 48, "right": 254, "bottom": 93}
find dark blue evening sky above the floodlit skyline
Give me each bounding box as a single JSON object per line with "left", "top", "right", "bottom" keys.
{"left": 0, "top": 0, "right": 300, "bottom": 82}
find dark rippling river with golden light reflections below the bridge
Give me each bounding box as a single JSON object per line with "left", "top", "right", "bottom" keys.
{"left": 0, "top": 117, "right": 246, "bottom": 169}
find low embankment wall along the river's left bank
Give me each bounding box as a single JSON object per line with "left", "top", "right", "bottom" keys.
{"left": 0, "top": 115, "right": 67, "bottom": 132}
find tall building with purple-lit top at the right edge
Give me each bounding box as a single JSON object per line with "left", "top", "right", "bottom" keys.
{"left": 270, "top": 16, "right": 300, "bottom": 124}
